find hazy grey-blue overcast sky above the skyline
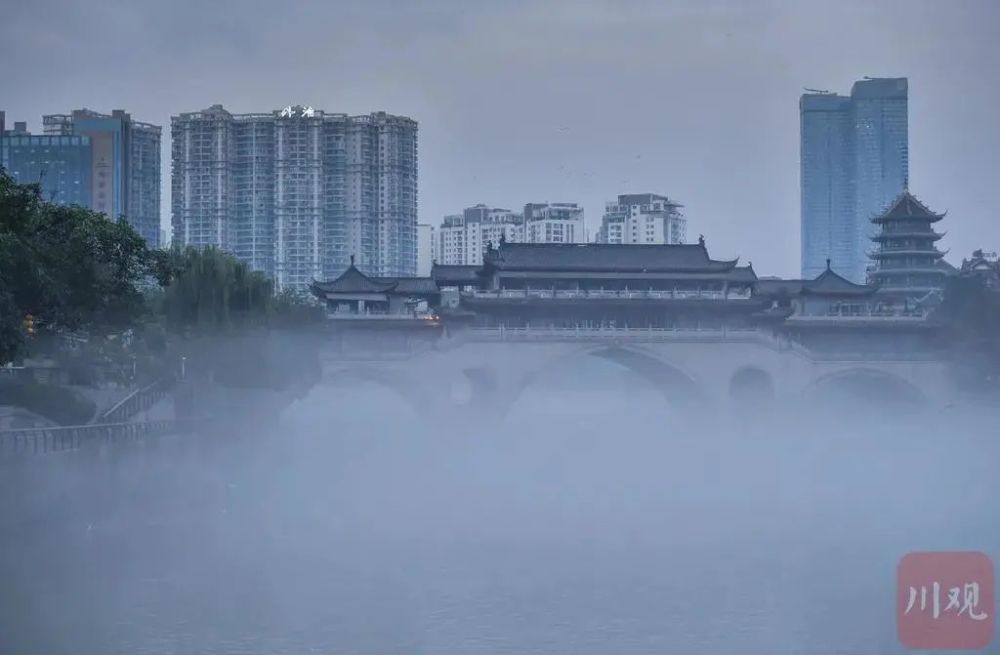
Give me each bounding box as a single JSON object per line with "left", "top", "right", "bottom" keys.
{"left": 0, "top": 0, "right": 1000, "bottom": 277}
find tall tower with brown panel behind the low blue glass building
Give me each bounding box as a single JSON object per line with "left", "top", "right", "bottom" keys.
{"left": 42, "top": 109, "right": 162, "bottom": 247}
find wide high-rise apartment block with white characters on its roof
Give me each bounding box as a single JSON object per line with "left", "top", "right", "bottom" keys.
{"left": 171, "top": 105, "right": 417, "bottom": 288}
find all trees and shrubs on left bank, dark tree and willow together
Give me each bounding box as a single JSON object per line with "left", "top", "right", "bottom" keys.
{"left": 0, "top": 169, "right": 322, "bottom": 422}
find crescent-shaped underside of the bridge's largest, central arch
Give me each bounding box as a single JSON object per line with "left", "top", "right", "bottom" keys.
{"left": 500, "top": 344, "right": 707, "bottom": 416}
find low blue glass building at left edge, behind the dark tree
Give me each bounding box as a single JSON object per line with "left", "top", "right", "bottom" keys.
{"left": 0, "top": 112, "right": 91, "bottom": 207}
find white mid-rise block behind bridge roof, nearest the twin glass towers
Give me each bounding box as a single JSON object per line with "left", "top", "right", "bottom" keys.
{"left": 597, "top": 193, "right": 687, "bottom": 244}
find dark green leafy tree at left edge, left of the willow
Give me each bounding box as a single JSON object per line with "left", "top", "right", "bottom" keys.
{"left": 0, "top": 170, "right": 167, "bottom": 363}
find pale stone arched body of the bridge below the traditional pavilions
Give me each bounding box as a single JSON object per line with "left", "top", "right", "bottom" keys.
{"left": 324, "top": 328, "right": 955, "bottom": 421}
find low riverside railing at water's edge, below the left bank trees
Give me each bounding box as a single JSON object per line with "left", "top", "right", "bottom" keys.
{"left": 0, "top": 418, "right": 205, "bottom": 457}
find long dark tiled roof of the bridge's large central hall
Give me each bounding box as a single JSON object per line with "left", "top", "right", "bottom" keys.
{"left": 483, "top": 242, "right": 740, "bottom": 277}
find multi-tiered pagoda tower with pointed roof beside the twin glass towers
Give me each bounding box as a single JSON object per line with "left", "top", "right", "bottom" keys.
{"left": 870, "top": 191, "right": 949, "bottom": 300}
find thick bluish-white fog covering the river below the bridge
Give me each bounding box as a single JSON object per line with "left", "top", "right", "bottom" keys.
{"left": 0, "top": 359, "right": 1000, "bottom": 655}
